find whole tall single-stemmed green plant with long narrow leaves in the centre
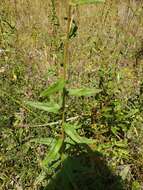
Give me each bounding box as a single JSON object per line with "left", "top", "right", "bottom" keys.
{"left": 26, "top": 0, "right": 102, "bottom": 184}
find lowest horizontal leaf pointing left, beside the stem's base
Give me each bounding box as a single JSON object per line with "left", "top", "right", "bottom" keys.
{"left": 30, "top": 137, "right": 55, "bottom": 146}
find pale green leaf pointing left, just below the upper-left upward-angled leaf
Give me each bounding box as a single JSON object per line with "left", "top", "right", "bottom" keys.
{"left": 26, "top": 101, "right": 61, "bottom": 113}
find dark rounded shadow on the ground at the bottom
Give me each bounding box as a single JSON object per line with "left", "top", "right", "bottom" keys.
{"left": 44, "top": 147, "right": 124, "bottom": 190}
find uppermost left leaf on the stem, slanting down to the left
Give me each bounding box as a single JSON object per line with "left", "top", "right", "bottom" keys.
{"left": 40, "top": 79, "right": 65, "bottom": 97}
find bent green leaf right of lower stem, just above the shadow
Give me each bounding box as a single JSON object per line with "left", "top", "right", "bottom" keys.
{"left": 64, "top": 123, "right": 95, "bottom": 144}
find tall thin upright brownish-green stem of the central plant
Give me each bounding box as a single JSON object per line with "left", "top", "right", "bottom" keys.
{"left": 61, "top": 5, "right": 71, "bottom": 140}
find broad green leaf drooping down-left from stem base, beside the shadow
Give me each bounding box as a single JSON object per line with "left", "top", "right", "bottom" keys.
{"left": 42, "top": 138, "right": 63, "bottom": 167}
